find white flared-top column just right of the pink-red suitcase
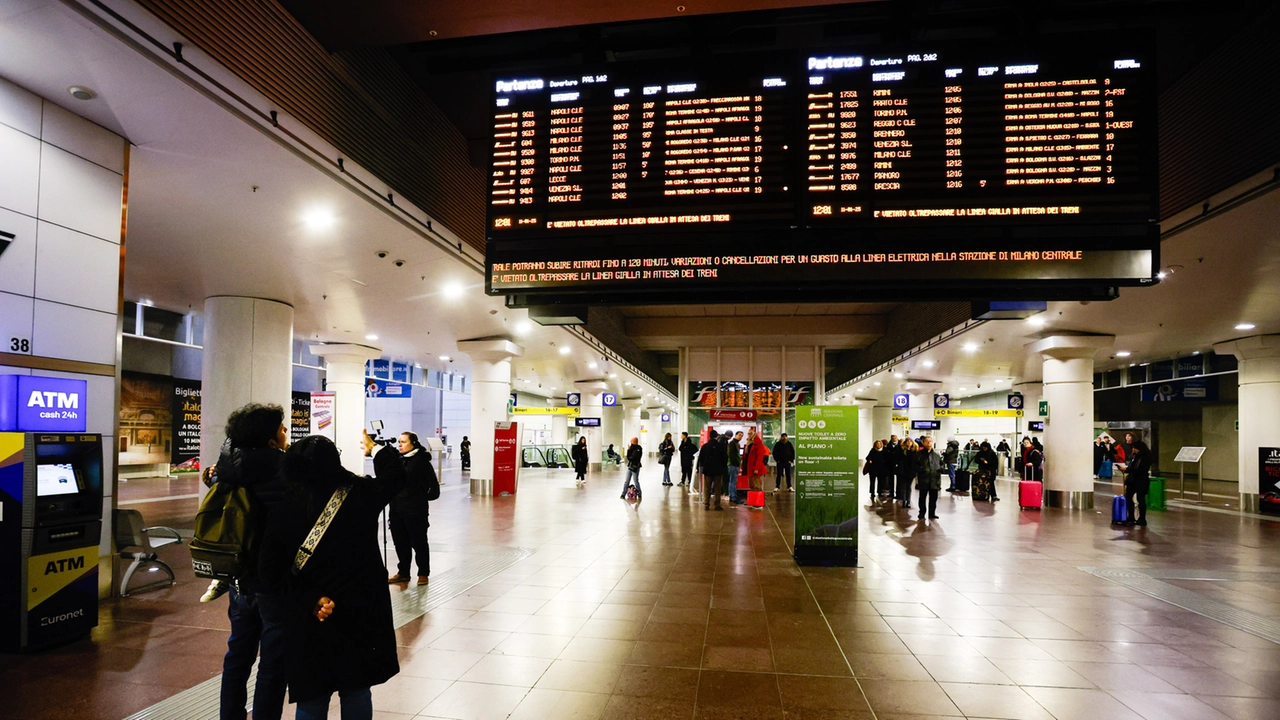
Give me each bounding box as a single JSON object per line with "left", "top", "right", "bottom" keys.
{"left": 1024, "top": 336, "right": 1115, "bottom": 510}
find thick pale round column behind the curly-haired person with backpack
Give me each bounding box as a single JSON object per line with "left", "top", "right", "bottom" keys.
{"left": 200, "top": 296, "right": 293, "bottom": 484}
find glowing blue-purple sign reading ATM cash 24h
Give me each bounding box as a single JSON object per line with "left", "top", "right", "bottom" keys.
{"left": 0, "top": 375, "right": 88, "bottom": 433}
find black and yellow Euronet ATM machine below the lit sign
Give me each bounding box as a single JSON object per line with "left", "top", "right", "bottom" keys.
{"left": 0, "top": 432, "right": 102, "bottom": 652}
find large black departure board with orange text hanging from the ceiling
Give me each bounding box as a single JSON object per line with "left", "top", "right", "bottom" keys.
{"left": 488, "top": 41, "right": 1158, "bottom": 295}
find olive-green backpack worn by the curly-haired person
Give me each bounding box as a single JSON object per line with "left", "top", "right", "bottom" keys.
{"left": 188, "top": 483, "right": 261, "bottom": 580}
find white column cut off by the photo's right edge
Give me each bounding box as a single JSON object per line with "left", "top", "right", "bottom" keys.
{"left": 1213, "top": 334, "right": 1280, "bottom": 512}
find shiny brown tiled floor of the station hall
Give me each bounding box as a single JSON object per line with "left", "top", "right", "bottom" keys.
{"left": 0, "top": 458, "right": 1280, "bottom": 720}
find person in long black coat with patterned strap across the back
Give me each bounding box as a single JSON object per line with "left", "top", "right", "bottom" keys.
{"left": 260, "top": 433, "right": 406, "bottom": 720}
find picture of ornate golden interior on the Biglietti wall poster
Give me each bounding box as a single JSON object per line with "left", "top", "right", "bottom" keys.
{"left": 118, "top": 373, "right": 173, "bottom": 465}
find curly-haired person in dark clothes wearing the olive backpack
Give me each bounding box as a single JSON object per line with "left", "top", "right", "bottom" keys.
{"left": 210, "top": 404, "right": 289, "bottom": 720}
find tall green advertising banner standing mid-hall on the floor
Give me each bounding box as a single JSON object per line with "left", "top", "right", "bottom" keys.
{"left": 795, "top": 406, "right": 858, "bottom": 566}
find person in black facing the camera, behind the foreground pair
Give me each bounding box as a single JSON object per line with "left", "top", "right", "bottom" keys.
{"left": 387, "top": 433, "right": 440, "bottom": 585}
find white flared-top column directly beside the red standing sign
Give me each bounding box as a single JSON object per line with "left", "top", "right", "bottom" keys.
{"left": 458, "top": 340, "right": 525, "bottom": 495}
